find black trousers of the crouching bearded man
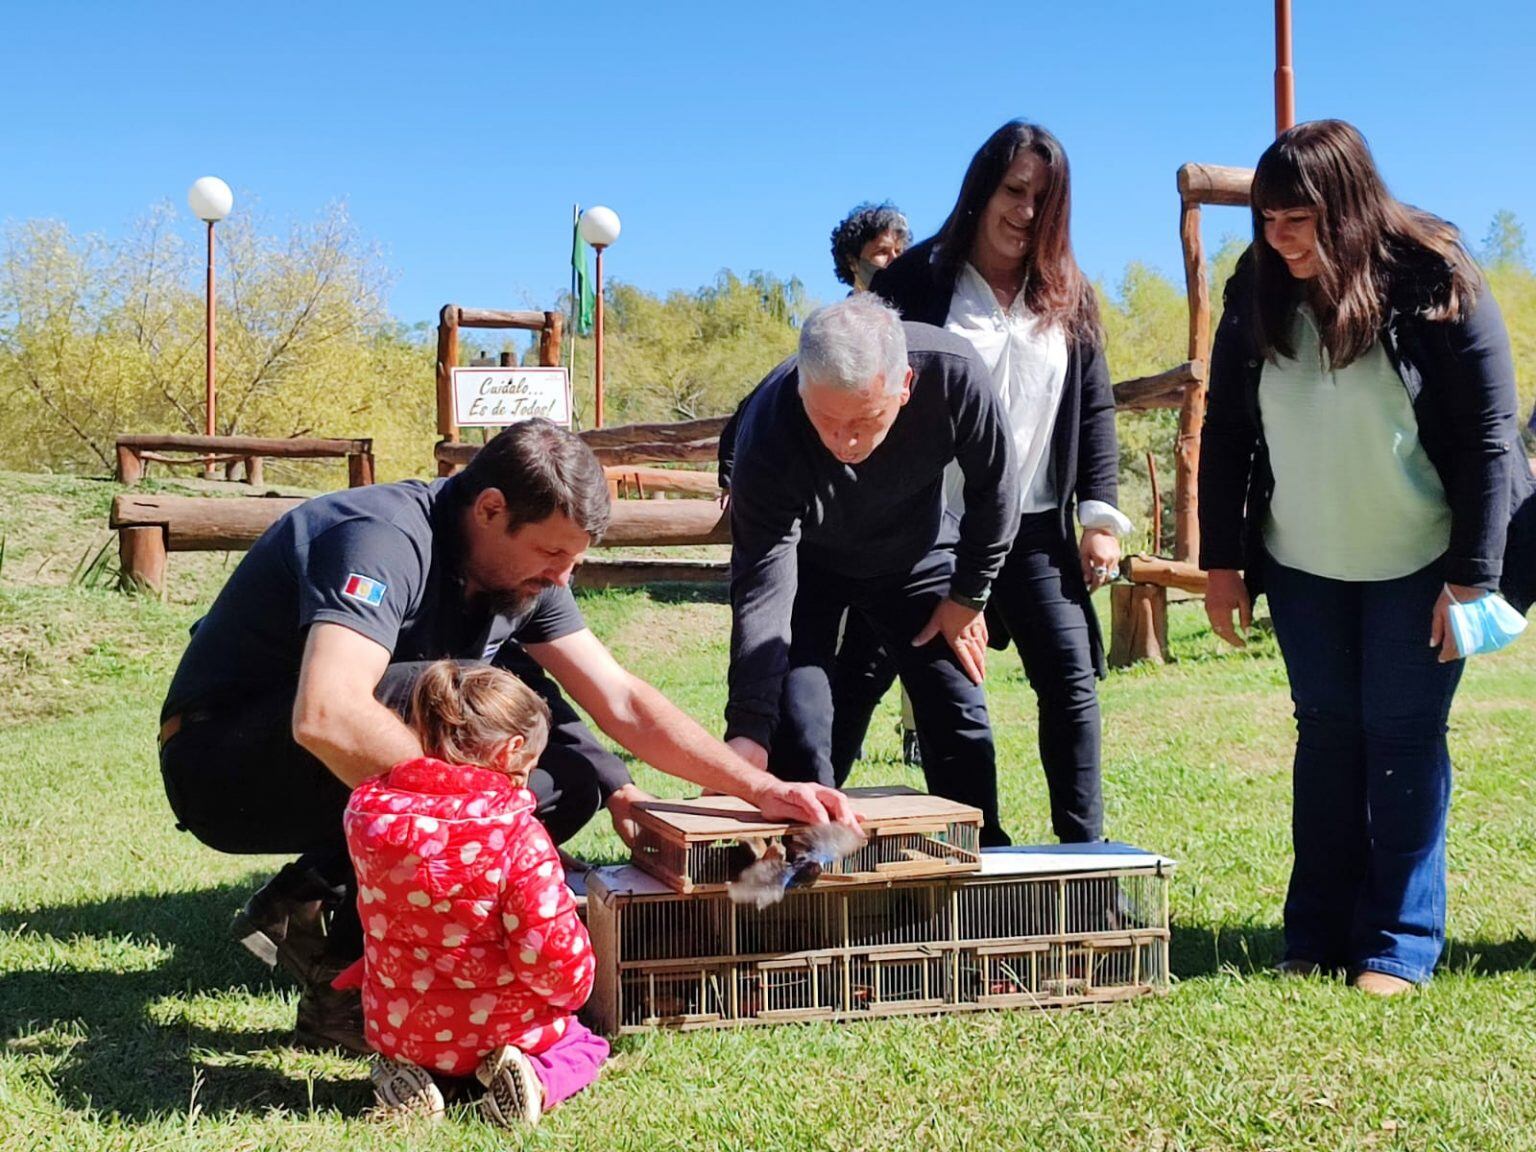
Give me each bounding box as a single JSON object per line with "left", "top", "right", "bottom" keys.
{"left": 160, "top": 645, "right": 611, "bottom": 962}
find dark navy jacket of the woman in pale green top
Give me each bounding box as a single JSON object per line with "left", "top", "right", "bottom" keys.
{"left": 1200, "top": 252, "right": 1531, "bottom": 599}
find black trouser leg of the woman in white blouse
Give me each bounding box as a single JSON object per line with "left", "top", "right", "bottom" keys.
{"left": 992, "top": 511, "right": 1104, "bottom": 843}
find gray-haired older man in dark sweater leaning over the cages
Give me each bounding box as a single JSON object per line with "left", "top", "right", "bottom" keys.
{"left": 725, "top": 295, "right": 1018, "bottom": 843}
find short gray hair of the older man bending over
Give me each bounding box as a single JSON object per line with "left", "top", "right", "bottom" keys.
{"left": 799, "top": 292, "right": 908, "bottom": 396}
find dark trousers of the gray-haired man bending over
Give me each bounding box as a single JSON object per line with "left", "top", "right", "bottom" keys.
{"left": 768, "top": 551, "right": 1008, "bottom": 845}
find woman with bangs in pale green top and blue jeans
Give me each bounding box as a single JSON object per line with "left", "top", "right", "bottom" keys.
{"left": 1200, "top": 120, "right": 1531, "bottom": 995}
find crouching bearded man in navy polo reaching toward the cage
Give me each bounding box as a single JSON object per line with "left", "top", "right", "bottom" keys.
{"left": 160, "top": 419, "right": 854, "bottom": 1051}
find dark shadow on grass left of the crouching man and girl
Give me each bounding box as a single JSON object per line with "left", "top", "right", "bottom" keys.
{"left": 0, "top": 885, "right": 372, "bottom": 1120}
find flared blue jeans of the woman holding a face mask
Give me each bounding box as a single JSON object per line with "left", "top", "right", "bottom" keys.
{"left": 1264, "top": 561, "right": 1464, "bottom": 983}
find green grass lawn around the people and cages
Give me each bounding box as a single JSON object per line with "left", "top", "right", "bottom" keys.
{"left": 0, "top": 475, "right": 1536, "bottom": 1152}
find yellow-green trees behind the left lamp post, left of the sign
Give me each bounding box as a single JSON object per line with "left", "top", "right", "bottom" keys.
{"left": 0, "top": 206, "right": 435, "bottom": 475}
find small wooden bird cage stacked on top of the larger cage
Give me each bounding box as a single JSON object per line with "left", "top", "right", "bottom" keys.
{"left": 633, "top": 786, "right": 982, "bottom": 892}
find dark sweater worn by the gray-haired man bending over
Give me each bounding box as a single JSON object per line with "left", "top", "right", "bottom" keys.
{"left": 722, "top": 324, "right": 1018, "bottom": 748}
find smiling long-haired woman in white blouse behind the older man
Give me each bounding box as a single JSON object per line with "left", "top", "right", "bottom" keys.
{"left": 872, "top": 120, "right": 1130, "bottom": 842}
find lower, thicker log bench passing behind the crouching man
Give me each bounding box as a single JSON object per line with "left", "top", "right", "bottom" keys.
{"left": 109, "top": 492, "right": 731, "bottom": 596}
